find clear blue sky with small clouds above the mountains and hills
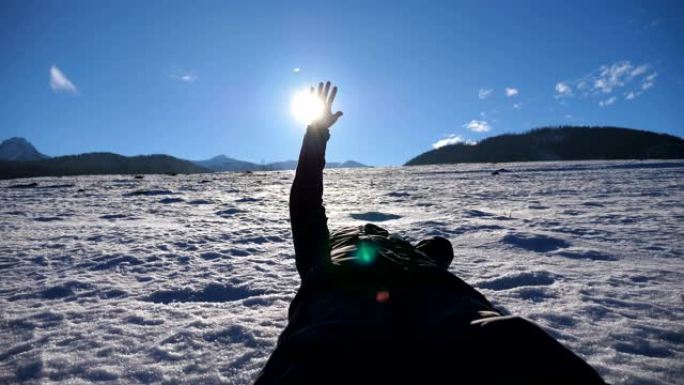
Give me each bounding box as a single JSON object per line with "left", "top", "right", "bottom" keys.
{"left": 0, "top": 0, "right": 684, "bottom": 165}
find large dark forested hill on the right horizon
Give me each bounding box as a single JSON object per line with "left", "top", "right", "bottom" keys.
{"left": 406, "top": 126, "right": 684, "bottom": 166}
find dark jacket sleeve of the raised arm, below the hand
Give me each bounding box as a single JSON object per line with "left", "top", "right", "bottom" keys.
{"left": 290, "top": 126, "right": 330, "bottom": 279}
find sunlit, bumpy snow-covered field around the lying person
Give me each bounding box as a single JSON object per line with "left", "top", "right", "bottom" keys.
{"left": 0, "top": 161, "right": 684, "bottom": 384}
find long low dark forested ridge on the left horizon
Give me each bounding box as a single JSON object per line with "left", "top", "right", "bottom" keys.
{"left": 0, "top": 152, "right": 210, "bottom": 179}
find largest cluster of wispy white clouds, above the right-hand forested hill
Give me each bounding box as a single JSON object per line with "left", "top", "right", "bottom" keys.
{"left": 555, "top": 60, "right": 658, "bottom": 103}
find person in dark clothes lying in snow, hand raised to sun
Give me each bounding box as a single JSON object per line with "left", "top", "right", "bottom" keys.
{"left": 255, "top": 82, "right": 604, "bottom": 385}
